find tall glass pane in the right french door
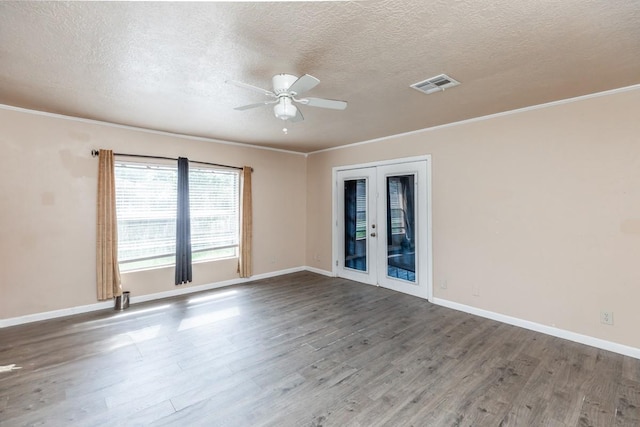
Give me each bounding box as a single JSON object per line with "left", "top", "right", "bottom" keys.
{"left": 386, "top": 175, "right": 416, "bottom": 282}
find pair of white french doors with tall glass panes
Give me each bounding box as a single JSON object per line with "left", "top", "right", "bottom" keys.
{"left": 334, "top": 160, "right": 431, "bottom": 298}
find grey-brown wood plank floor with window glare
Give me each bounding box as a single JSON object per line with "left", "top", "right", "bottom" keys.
{"left": 0, "top": 272, "right": 640, "bottom": 427}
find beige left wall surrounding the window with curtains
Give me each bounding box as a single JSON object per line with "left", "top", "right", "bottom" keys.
{"left": 0, "top": 109, "right": 306, "bottom": 319}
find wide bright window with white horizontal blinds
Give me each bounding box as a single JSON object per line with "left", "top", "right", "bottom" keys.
{"left": 115, "top": 162, "right": 240, "bottom": 271}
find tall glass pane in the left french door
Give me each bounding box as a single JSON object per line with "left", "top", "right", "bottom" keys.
{"left": 344, "top": 179, "right": 367, "bottom": 271}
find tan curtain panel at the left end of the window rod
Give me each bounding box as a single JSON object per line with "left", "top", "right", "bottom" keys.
{"left": 96, "top": 150, "right": 122, "bottom": 301}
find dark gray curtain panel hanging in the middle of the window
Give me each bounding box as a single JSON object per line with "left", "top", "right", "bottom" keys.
{"left": 176, "top": 157, "right": 193, "bottom": 285}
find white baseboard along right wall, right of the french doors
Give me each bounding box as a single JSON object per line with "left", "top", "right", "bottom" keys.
{"left": 431, "top": 298, "right": 640, "bottom": 359}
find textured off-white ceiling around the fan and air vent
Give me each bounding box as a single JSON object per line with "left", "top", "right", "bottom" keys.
{"left": 0, "top": 0, "right": 640, "bottom": 152}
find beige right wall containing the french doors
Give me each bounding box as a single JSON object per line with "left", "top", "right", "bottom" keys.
{"left": 307, "top": 89, "right": 640, "bottom": 348}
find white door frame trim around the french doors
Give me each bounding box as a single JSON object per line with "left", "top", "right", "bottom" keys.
{"left": 331, "top": 154, "right": 433, "bottom": 301}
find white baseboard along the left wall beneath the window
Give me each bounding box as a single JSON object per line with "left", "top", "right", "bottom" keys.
{"left": 0, "top": 267, "right": 310, "bottom": 329}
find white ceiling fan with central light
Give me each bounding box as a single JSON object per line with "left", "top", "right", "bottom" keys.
{"left": 227, "top": 74, "right": 347, "bottom": 122}
